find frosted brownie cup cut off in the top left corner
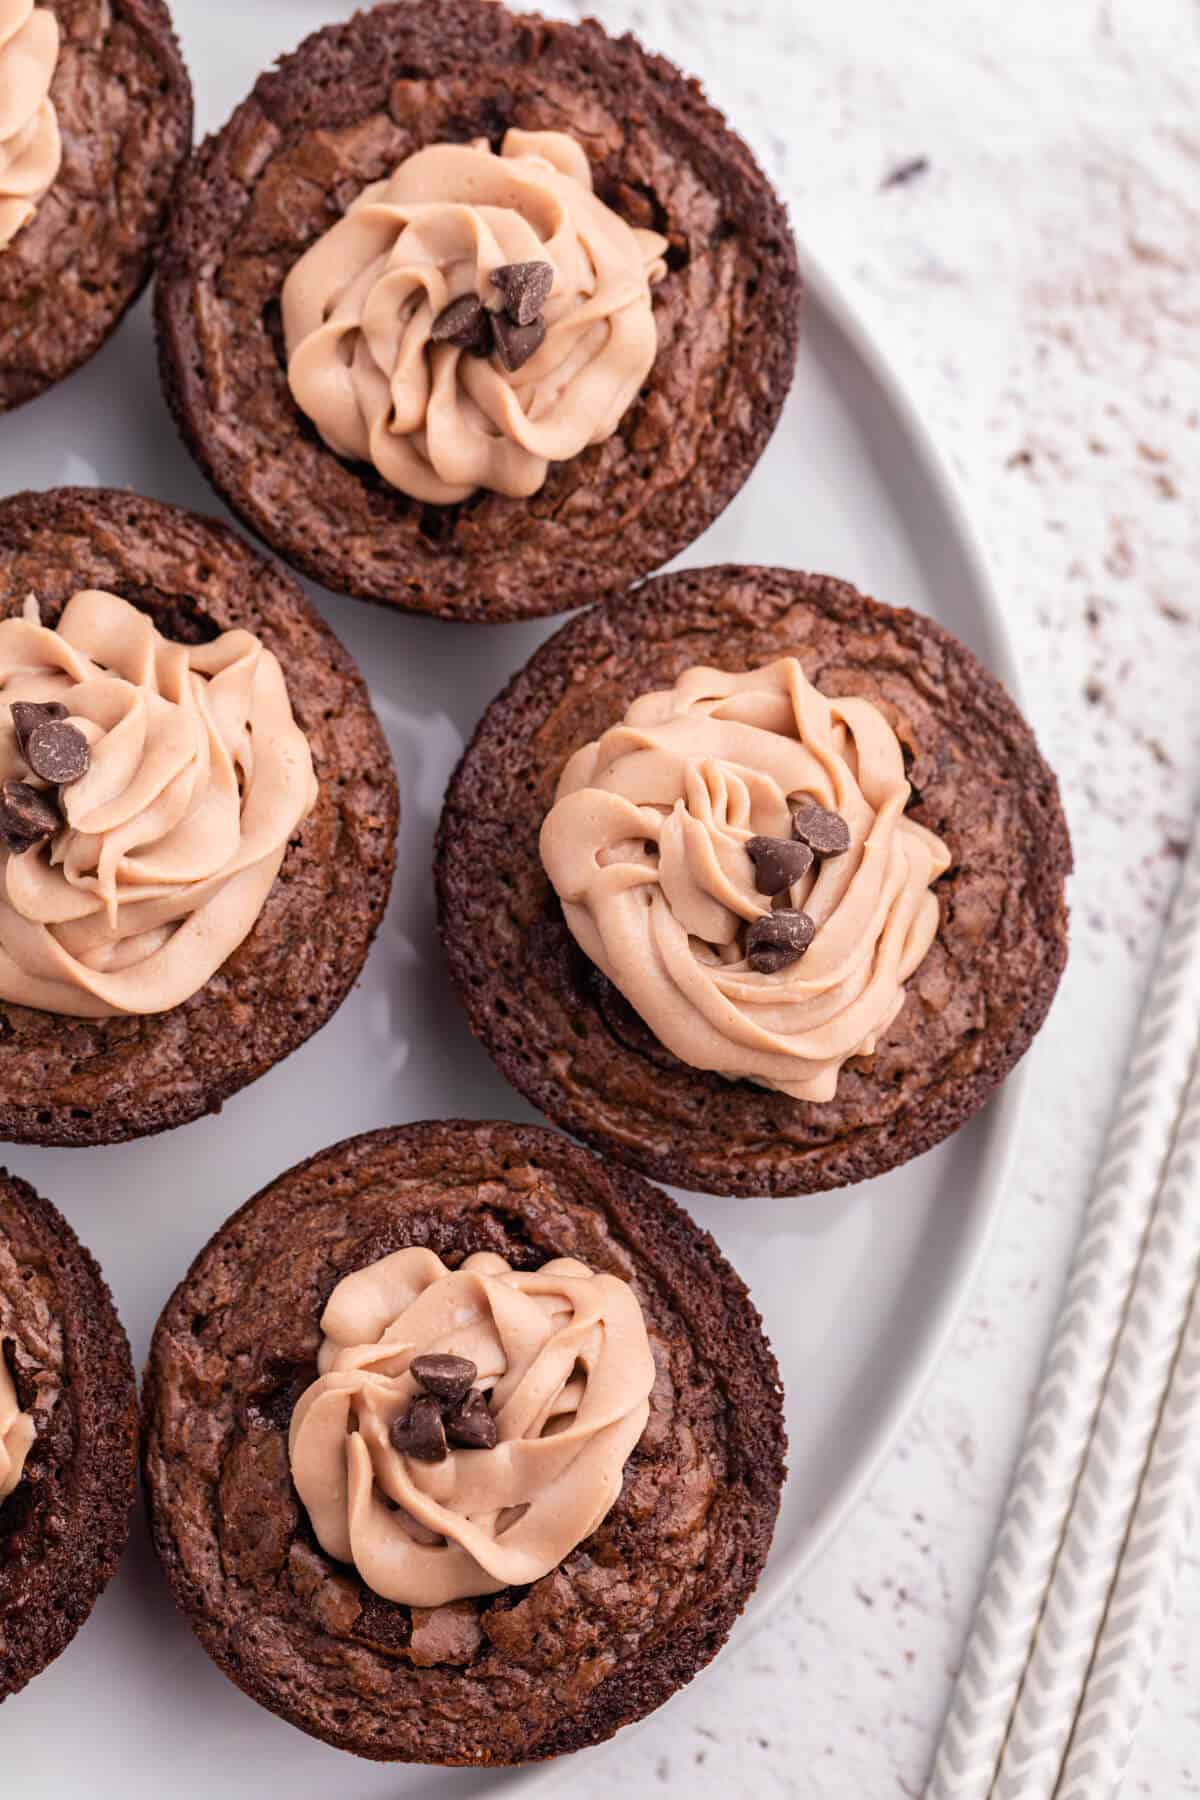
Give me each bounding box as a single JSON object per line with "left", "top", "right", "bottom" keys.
{"left": 0, "top": 0, "right": 193, "bottom": 410}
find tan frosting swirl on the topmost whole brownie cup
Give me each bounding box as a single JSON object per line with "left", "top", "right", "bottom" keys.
{"left": 282, "top": 130, "right": 666, "bottom": 502}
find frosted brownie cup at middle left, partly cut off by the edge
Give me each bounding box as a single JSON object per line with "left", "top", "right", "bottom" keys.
{"left": 0, "top": 488, "right": 398, "bottom": 1145}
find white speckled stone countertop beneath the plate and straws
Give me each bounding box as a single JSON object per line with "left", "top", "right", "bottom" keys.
{"left": 543, "top": 0, "right": 1200, "bottom": 1800}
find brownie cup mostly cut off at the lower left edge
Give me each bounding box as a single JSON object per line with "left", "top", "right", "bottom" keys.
{"left": 0, "top": 1170, "right": 137, "bottom": 1701}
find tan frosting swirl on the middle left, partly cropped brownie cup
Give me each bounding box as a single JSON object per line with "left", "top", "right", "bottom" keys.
{"left": 0, "top": 590, "right": 317, "bottom": 1019}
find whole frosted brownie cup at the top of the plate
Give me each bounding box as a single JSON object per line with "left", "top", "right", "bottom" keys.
{"left": 157, "top": 0, "right": 801, "bottom": 621}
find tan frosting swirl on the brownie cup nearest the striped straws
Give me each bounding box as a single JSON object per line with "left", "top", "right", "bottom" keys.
{"left": 542, "top": 657, "right": 950, "bottom": 1100}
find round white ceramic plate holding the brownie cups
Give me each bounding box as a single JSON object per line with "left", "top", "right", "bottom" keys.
{"left": 0, "top": 0, "right": 1016, "bottom": 1800}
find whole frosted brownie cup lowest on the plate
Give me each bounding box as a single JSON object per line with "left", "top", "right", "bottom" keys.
{"left": 144, "top": 1121, "right": 784, "bottom": 1766}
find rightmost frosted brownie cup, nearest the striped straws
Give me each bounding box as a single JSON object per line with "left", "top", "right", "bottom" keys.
{"left": 437, "top": 567, "right": 1070, "bottom": 1193}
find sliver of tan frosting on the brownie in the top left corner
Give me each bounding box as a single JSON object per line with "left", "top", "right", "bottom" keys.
{"left": 0, "top": 0, "right": 63, "bottom": 248}
